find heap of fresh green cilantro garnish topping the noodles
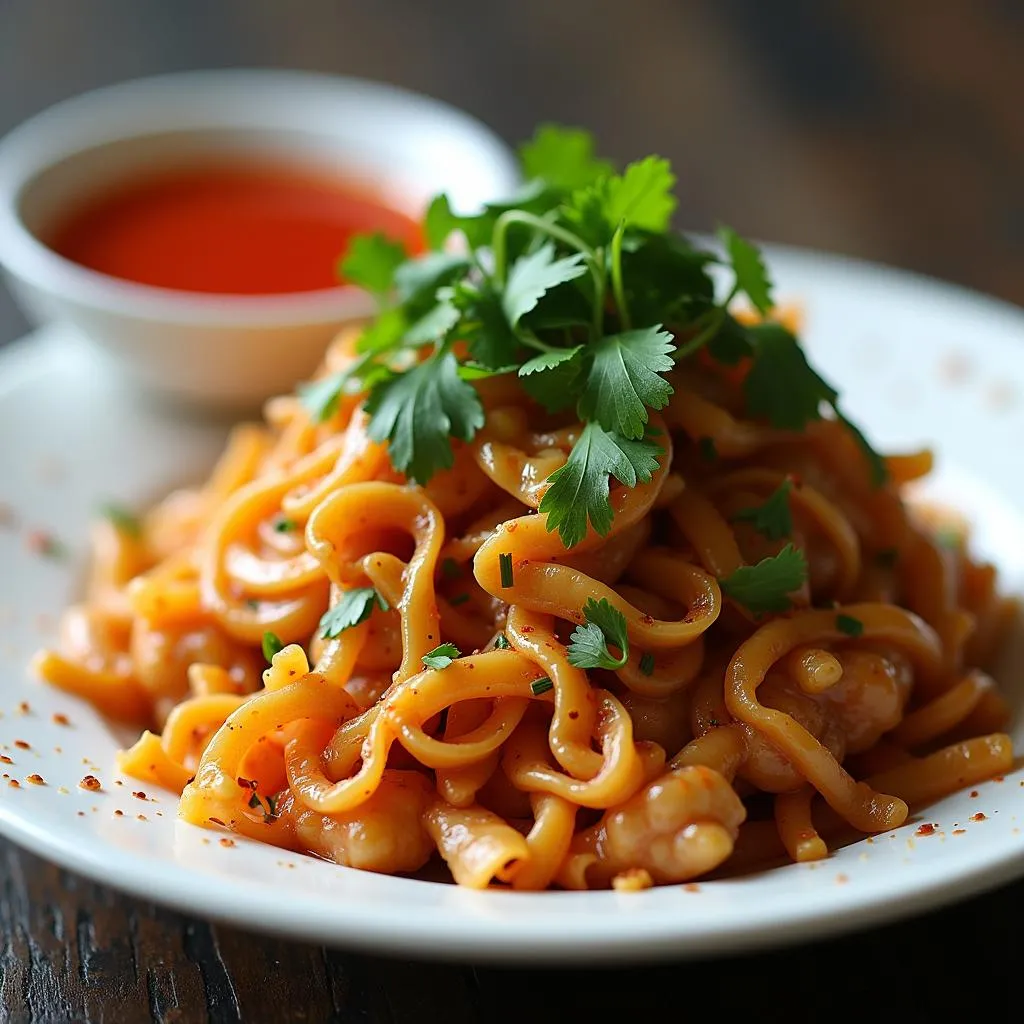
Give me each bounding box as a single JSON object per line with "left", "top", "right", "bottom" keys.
{"left": 300, "top": 125, "right": 886, "bottom": 613}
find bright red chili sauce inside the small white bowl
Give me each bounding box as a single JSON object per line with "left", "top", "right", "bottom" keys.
{"left": 44, "top": 166, "right": 423, "bottom": 295}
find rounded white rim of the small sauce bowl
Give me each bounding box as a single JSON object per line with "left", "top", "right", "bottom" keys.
{"left": 0, "top": 68, "right": 519, "bottom": 329}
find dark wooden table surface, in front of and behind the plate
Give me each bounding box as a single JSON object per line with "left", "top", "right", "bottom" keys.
{"left": 0, "top": 0, "right": 1024, "bottom": 1024}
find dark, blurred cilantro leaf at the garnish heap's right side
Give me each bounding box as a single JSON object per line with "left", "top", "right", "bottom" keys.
{"left": 743, "top": 324, "right": 838, "bottom": 430}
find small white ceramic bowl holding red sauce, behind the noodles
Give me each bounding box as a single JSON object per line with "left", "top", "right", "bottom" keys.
{"left": 0, "top": 71, "right": 519, "bottom": 409}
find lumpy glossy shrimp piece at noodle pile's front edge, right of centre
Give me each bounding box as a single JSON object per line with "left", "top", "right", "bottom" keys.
{"left": 569, "top": 765, "right": 746, "bottom": 885}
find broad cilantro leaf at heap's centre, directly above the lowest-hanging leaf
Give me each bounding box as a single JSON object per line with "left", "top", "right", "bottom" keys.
{"left": 580, "top": 327, "right": 676, "bottom": 438}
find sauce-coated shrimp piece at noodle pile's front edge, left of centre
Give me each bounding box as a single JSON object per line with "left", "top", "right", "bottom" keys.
{"left": 291, "top": 768, "right": 434, "bottom": 874}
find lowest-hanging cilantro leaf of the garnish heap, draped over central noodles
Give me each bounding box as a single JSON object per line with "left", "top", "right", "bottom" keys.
{"left": 540, "top": 419, "right": 664, "bottom": 548}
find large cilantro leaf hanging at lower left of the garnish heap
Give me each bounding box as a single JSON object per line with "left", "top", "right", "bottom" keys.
{"left": 367, "top": 351, "right": 483, "bottom": 483}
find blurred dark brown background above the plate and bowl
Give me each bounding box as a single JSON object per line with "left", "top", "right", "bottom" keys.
{"left": 0, "top": 0, "right": 1024, "bottom": 342}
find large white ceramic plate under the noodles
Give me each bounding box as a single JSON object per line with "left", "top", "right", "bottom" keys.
{"left": 0, "top": 249, "right": 1024, "bottom": 963}
